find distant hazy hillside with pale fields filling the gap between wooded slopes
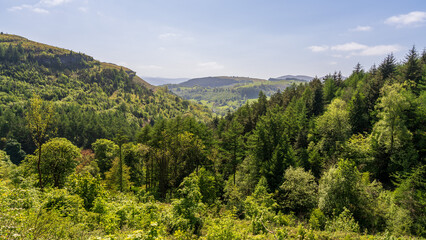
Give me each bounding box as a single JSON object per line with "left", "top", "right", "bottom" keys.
{"left": 167, "top": 76, "right": 305, "bottom": 115}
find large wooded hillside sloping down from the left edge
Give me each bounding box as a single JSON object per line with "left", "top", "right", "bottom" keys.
{"left": 0, "top": 34, "right": 211, "bottom": 151}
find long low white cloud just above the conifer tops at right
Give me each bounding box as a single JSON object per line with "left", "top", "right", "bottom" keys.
{"left": 309, "top": 42, "right": 402, "bottom": 58}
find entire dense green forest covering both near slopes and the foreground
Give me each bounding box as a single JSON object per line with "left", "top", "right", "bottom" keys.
{"left": 0, "top": 35, "right": 426, "bottom": 239}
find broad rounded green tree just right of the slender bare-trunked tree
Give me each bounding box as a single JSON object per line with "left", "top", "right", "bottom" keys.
{"left": 36, "top": 138, "right": 80, "bottom": 188}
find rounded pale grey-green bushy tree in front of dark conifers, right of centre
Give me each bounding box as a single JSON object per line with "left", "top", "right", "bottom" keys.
{"left": 278, "top": 167, "right": 318, "bottom": 214}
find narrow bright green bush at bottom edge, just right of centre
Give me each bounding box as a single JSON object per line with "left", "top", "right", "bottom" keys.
{"left": 244, "top": 177, "right": 277, "bottom": 234}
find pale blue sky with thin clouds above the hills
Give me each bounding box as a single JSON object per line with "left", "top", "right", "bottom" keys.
{"left": 0, "top": 0, "right": 426, "bottom": 84}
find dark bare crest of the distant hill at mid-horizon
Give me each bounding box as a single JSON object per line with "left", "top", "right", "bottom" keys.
{"left": 174, "top": 76, "right": 266, "bottom": 88}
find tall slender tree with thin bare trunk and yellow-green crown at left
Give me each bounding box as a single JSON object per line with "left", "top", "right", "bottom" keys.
{"left": 26, "top": 96, "right": 55, "bottom": 190}
